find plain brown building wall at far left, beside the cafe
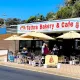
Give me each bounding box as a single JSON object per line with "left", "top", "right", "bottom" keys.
{"left": 0, "top": 40, "right": 19, "bottom": 53}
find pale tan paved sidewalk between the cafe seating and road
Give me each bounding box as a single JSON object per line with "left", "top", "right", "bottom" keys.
{"left": 0, "top": 62, "right": 80, "bottom": 79}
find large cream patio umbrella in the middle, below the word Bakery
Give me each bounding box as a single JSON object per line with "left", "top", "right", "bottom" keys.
{"left": 21, "top": 32, "right": 54, "bottom": 40}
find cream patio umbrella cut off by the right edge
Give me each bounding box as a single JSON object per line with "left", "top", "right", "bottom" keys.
{"left": 57, "top": 31, "right": 80, "bottom": 39}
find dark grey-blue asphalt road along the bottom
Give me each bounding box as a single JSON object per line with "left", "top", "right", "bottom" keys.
{"left": 0, "top": 66, "right": 77, "bottom": 80}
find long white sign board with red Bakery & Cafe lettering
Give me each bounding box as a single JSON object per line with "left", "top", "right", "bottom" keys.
{"left": 17, "top": 18, "right": 80, "bottom": 33}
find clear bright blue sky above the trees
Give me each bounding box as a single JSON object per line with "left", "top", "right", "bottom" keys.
{"left": 0, "top": 0, "right": 64, "bottom": 20}
